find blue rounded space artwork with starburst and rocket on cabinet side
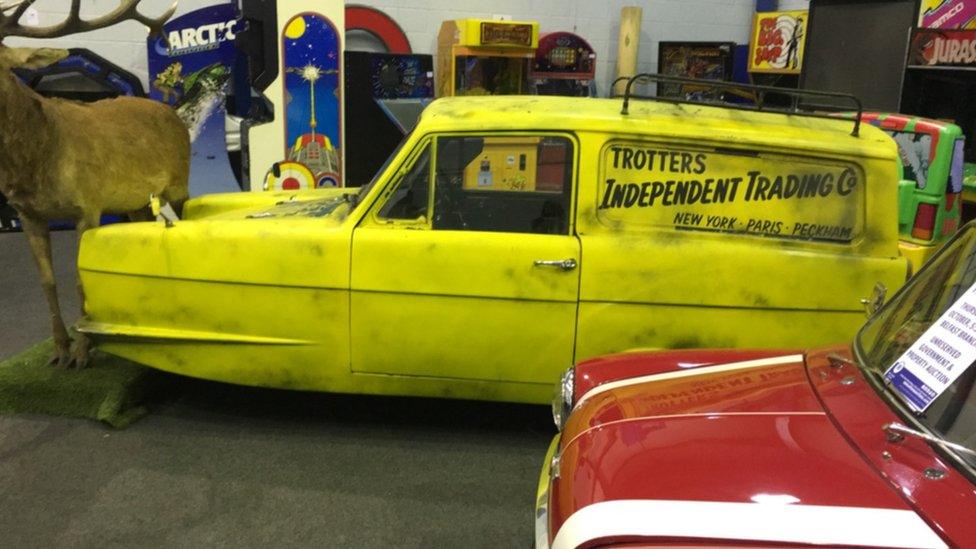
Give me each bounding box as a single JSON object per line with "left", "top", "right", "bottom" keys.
{"left": 264, "top": 13, "right": 342, "bottom": 190}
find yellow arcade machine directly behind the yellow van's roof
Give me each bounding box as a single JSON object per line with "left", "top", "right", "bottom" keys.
{"left": 436, "top": 19, "right": 539, "bottom": 97}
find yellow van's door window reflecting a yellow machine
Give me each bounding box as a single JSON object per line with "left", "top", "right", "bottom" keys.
{"left": 433, "top": 135, "right": 573, "bottom": 234}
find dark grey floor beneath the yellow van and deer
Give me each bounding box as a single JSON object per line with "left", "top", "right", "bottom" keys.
{"left": 0, "top": 232, "right": 553, "bottom": 547}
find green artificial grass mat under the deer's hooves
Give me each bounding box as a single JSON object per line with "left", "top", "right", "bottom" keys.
{"left": 0, "top": 339, "right": 166, "bottom": 429}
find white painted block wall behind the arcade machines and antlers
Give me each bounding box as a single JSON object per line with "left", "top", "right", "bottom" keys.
{"left": 0, "top": 0, "right": 760, "bottom": 94}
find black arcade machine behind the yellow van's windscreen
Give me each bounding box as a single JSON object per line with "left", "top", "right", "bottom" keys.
{"left": 344, "top": 51, "right": 434, "bottom": 186}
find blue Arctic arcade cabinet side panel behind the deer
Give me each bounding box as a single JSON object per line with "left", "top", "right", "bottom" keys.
{"left": 147, "top": 3, "right": 241, "bottom": 196}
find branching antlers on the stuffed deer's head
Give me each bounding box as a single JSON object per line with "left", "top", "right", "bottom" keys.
{"left": 0, "top": 0, "right": 178, "bottom": 40}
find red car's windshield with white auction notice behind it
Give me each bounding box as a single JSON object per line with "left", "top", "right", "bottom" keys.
{"left": 855, "top": 224, "right": 976, "bottom": 467}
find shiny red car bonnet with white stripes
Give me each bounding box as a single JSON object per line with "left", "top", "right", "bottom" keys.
{"left": 549, "top": 351, "right": 938, "bottom": 545}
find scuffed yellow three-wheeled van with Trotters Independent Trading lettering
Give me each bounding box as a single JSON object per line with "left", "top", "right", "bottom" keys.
{"left": 77, "top": 97, "right": 907, "bottom": 403}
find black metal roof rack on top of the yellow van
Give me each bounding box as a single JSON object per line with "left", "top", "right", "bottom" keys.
{"left": 611, "top": 73, "right": 864, "bottom": 137}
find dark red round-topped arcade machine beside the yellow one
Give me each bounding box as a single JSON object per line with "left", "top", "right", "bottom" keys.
{"left": 529, "top": 32, "right": 596, "bottom": 97}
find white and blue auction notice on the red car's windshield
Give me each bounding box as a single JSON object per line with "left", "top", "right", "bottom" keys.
{"left": 885, "top": 284, "right": 976, "bottom": 412}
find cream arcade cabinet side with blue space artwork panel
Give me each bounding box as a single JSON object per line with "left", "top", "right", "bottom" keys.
{"left": 238, "top": 0, "right": 345, "bottom": 191}
